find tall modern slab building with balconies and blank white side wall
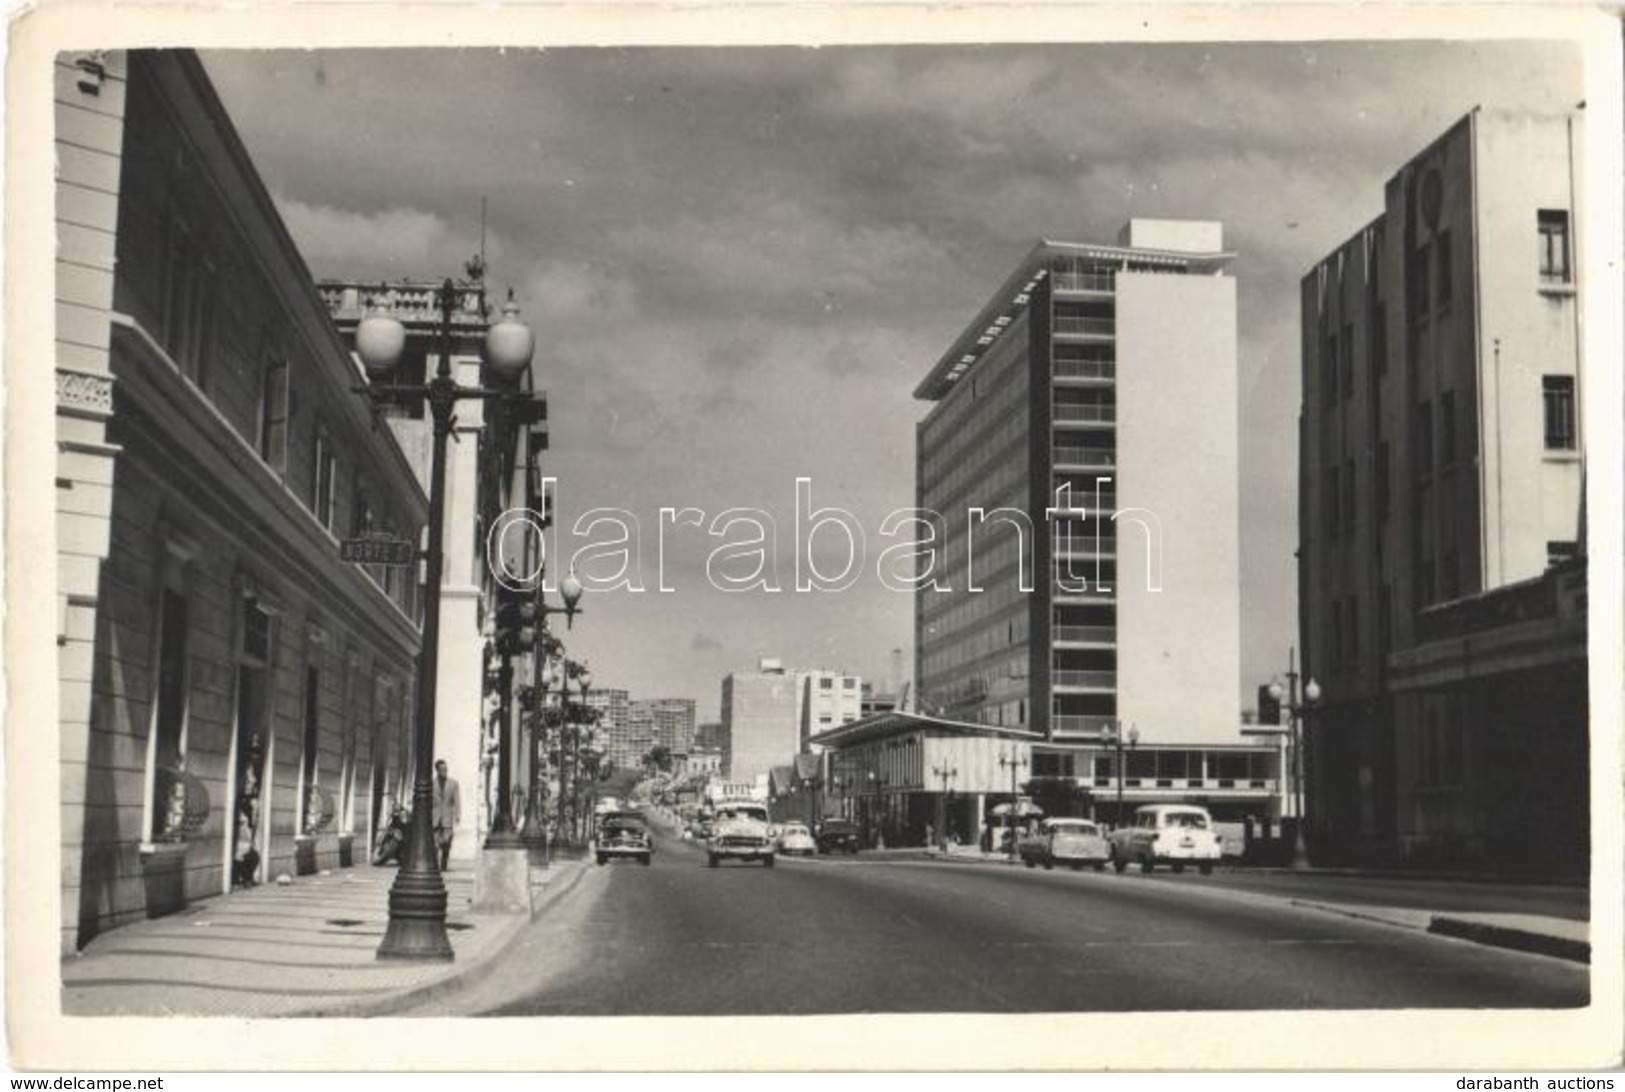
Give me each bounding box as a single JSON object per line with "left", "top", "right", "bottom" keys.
{"left": 915, "top": 219, "right": 1281, "bottom": 817}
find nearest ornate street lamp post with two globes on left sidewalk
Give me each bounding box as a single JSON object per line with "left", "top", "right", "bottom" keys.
{"left": 356, "top": 278, "right": 535, "bottom": 962}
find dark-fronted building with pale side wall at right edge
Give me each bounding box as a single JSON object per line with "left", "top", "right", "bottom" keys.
{"left": 1298, "top": 111, "right": 1586, "bottom": 868}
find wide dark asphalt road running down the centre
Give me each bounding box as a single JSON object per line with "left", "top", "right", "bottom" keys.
{"left": 421, "top": 832, "right": 1589, "bottom": 1016}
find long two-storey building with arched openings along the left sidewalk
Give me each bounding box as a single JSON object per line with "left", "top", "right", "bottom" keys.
{"left": 55, "top": 50, "right": 427, "bottom": 951}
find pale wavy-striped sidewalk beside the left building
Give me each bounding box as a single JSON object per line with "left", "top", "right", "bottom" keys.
{"left": 62, "top": 860, "right": 585, "bottom": 1017}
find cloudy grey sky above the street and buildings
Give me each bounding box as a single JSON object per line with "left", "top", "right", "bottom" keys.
{"left": 203, "top": 42, "right": 1583, "bottom": 717}
